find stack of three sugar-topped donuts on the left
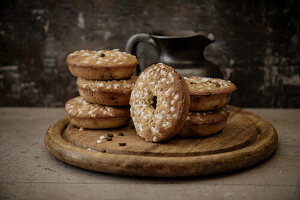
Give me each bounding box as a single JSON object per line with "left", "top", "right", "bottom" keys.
{"left": 65, "top": 49, "right": 138, "bottom": 130}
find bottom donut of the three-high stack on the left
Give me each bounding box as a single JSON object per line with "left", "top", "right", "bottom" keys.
{"left": 65, "top": 97, "right": 130, "bottom": 129}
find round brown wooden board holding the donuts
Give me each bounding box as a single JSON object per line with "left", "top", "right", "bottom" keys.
{"left": 45, "top": 106, "right": 278, "bottom": 177}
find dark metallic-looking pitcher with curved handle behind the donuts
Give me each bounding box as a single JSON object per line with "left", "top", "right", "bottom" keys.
{"left": 126, "top": 30, "right": 223, "bottom": 78}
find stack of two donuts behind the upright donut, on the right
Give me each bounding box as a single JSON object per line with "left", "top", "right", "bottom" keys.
{"left": 178, "top": 76, "right": 237, "bottom": 137}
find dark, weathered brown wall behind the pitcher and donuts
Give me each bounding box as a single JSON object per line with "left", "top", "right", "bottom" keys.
{"left": 0, "top": 0, "right": 300, "bottom": 107}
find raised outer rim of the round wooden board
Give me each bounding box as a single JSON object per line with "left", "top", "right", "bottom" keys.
{"left": 45, "top": 109, "right": 278, "bottom": 177}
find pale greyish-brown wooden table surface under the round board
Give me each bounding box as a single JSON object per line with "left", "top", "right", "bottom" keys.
{"left": 0, "top": 108, "right": 300, "bottom": 200}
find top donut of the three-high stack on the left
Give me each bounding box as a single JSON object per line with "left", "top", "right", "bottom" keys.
{"left": 67, "top": 49, "right": 138, "bottom": 80}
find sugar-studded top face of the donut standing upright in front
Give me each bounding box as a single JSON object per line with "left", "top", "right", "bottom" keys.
{"left": 130, "top": 63, "right": 182, "bottom": 142}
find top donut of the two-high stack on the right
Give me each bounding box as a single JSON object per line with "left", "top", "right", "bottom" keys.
{"left": 185, "top": 76, "right": 237, "bottom": 111}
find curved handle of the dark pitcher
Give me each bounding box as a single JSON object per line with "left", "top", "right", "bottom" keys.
{"left": 125, "top": 33, "right": 158, "bottom": 74}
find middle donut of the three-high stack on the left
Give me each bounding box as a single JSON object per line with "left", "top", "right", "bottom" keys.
{"left": 77, "top": 76, "right": 137, "bottom": 106}
